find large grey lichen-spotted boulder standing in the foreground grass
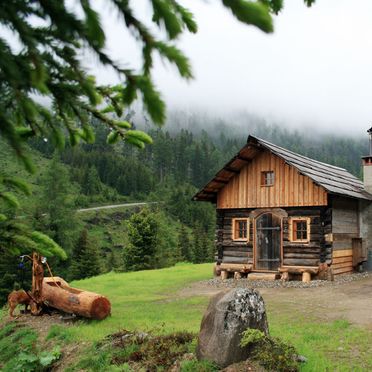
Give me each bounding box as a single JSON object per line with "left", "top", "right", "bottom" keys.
{"left": 196, "top": 288, "right": 269, "bottom": 367}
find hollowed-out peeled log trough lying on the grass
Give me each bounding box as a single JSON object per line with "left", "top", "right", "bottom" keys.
{"left": 42, "top": 276, "right": 111, "bottom": 320}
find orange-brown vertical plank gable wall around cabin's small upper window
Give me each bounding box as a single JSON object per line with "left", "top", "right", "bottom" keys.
{"left": 217, "top": 152, "right": 327, "bottom": 208}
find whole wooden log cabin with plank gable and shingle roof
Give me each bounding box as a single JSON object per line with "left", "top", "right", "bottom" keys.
{"left": 194, "top": 136, "right": 372, "bottom": 281}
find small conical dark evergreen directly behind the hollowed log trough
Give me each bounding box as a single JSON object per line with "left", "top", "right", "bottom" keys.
{"left": 69, "top": 229, "right": 102, "bottom": 279}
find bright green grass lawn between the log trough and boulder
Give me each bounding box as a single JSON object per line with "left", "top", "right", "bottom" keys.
{"left": 67, "top": 264, "right": 212, "bottom": 341}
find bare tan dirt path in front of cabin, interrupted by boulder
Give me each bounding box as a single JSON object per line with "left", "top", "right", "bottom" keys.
{"left": 178, "top": 277, "right": 372, "bottom": 330}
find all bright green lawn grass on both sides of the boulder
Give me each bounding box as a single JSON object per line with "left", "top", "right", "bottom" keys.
{"left": 2, "top": 264, "right": 372, "bottom": 371}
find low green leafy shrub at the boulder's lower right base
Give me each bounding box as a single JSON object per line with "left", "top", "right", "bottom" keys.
{"left": 240, "top": 329, "right": 299, "bottom": 372}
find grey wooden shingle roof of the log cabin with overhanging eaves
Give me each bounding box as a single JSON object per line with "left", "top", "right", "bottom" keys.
{"left": 193, "top": 136, "right": 372, "bottom": 202}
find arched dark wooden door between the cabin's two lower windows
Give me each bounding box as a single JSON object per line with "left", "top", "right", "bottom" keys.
{"left": 255, "top": 213, "right": 282, "bottom": 271}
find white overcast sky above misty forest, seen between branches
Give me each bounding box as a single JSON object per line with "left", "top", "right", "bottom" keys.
{"left": 88, "top": 0, "right": 372, "bottom": 134}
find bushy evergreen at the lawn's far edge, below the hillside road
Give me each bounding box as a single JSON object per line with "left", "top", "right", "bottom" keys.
{"left": 124, "top": 208, "right": 159, "bottom": 271}
